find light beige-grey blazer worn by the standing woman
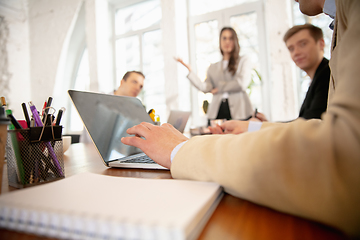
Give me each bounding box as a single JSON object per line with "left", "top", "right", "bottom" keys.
{"left": 187, "top": 56, "right": 253, "bottom": 119}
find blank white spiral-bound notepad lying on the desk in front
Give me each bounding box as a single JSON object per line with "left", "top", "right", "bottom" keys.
{"left": 0, "top": 173, "right": 222, "bottom": 239}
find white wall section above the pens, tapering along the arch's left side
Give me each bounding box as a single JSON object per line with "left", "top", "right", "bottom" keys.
{"left": 28, "top": 0, "right": 81, "bottom": 117}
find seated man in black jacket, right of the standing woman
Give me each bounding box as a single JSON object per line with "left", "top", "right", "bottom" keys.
{"left": 254, "top": 24, "right": 330, "bottom": 121}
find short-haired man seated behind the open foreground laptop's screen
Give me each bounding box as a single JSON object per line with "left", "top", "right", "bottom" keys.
{"left": 80, "top": 71, "right": 145, "bottom": 143}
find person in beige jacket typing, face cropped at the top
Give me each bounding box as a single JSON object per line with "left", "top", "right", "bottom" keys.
{"left": 122, "top": 0, "right": 360, "bottom": 236}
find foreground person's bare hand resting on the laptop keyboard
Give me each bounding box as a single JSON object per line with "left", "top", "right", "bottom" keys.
{"left": 121, "top": 122, "right": 188, "bottom": 168}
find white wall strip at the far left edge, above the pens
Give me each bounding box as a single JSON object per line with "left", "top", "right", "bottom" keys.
{"left": 0, "top": 0, "right": 32, "bottom": 118}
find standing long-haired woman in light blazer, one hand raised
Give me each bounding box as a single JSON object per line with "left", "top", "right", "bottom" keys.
{"left": 176, "top": 27, "right": 253, "bottom": 123}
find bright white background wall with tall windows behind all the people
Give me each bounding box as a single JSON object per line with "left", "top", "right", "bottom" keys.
{"left": 0, "top": 0, "right": 332, "bottom": 134}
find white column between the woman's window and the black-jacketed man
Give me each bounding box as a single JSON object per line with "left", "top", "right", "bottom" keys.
{"left": 265, "top": 0, "right": 299, "bottom": 121}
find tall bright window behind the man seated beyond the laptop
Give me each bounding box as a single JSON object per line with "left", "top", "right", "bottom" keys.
{"left": 115, "top": 0, "right": 166, "bottom": 122}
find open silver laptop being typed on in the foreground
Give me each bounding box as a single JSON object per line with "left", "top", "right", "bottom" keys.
{"left": 68, "top": 90, "right": 168, "bottom": 170}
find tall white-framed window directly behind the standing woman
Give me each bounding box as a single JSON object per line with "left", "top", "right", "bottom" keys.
{"left": 189, "top": 0, "right": 267, "bottom": 125}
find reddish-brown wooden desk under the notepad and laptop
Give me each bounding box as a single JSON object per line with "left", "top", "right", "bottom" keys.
{"left": 0, "top": 143, "right": 347, "bottom": 240}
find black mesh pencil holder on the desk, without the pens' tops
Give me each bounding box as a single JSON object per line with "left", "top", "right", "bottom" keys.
{"left": 6, "top": 126, "right": 65, "bottom": 188}
